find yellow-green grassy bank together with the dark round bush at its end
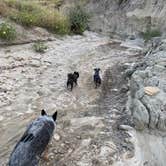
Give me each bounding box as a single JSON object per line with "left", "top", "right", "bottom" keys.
{"left": 0, "top": 0, "right": 89, "bottom": 35}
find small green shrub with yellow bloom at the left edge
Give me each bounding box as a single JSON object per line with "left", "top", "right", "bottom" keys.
{"left": 0, "top": 23, "right": 16, "bottom": 41}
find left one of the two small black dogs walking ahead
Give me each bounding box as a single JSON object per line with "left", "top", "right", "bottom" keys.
{"left": 67, "top": 71, "right": 79, "bottom": 91}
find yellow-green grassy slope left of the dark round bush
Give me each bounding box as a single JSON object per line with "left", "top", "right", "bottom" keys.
{"left": 0, "top": 0, "right": 70, "bottom": 34}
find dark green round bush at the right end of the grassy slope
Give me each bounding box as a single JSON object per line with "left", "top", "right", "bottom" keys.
{"left": 69, "top": 5, "right": 89, "bottom": 34}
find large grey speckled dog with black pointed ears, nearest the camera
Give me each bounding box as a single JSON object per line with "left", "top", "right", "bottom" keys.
{"left": 9, "top": 110, "right": 57, "bottom": 166}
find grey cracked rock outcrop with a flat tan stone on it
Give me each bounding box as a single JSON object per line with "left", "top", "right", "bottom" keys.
{"left": 128, "top": 40, "right": 166, "bottom": 131}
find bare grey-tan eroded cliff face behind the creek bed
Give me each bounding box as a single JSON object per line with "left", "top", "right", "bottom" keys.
{"left": 87, "top": 0, "right": 166, "bottom": 37}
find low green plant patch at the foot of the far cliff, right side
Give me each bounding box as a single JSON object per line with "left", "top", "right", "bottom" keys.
{"left": 141, "top": 29, "right": 161, "bottom": 41}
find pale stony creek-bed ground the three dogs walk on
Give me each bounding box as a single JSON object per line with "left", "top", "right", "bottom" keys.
{"left": 0, "top": 32, "right": 142, "bottom": 166}
